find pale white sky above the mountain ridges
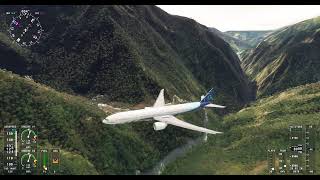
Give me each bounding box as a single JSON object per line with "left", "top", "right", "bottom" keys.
{"left": 158, "top": 5, "right": 320, "bottom": 31}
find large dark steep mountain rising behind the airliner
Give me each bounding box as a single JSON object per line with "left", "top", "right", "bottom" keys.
{"left": 0, "top": 5, "right": 254, "bottom": 109}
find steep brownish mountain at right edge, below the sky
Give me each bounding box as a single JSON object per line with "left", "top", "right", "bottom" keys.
{"left": 242, "top": 17, "right": 320, "bottom": 96}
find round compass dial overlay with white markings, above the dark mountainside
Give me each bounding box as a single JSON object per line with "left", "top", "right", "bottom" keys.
{"left": 9, "top": 10, "right": 43, "bottom": 46}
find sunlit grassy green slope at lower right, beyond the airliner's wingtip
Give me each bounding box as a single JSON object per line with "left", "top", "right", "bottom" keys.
{"left": 165, "top": 83, "right": 320, "bottom": 174}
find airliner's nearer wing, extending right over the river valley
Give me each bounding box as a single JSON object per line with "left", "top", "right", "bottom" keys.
{"left": 153, "top": 115, "right": 222, "bottom": 134}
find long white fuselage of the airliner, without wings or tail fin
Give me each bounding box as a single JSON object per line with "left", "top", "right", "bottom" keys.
{"left": 103, "top": 102, "right": 201, "bottom": 124}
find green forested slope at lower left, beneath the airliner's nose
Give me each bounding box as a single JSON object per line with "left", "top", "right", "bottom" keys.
{"left": 0, "top": 70, "right": 169, "bottom": 174}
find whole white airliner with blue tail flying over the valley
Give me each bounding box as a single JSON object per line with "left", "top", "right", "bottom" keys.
{"left": 102, "top": 89, "right": 225, "bottom": 134}
